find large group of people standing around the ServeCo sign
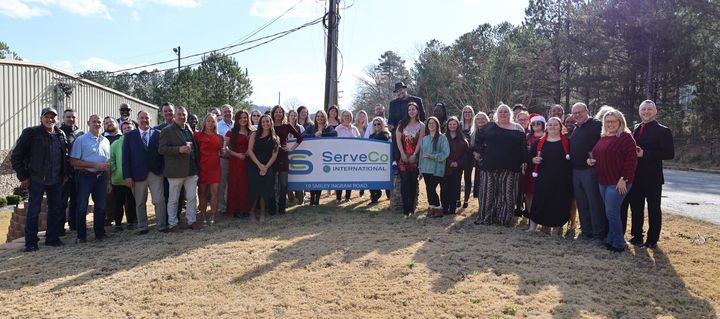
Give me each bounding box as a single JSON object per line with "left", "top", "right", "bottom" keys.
{"left": 12, "top": 82, "right": 674, "bottom": 252}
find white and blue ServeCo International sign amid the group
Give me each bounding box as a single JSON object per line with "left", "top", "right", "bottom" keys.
{"left": 288, "top": 137, "right": 392, "bottom": 190}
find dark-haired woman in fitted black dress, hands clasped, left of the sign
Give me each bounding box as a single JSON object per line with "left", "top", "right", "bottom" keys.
{"left": 247, "top": 115, "right": 280, "bottom": 223}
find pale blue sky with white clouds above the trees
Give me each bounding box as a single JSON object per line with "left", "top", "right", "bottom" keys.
{"left": 0, "top": 0, "right": 527, "bottom": 110}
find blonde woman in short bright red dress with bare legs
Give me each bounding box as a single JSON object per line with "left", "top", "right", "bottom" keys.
{"left": 194, "top": 114, "right": 223, "bottom": 224}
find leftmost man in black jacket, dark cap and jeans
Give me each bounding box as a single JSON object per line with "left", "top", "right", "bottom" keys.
{"left": 10, "top": 107, "right": 68, "bottom": 252}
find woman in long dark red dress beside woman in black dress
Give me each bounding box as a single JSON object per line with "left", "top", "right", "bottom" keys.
{"left": 225, "top": 110, "right": 255, "bottom": 218}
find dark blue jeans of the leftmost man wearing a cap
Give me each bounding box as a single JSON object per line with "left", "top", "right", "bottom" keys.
{"left": 25, "top": 180, "right": 65, "bottom": 246}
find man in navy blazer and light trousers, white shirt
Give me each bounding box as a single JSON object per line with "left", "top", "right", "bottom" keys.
{"left": 122, "top": 111, "right": 167, "bottom": 235}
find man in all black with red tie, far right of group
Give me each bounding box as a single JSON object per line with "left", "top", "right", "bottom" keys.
{"left": 621, "top": 100, "right": 675, "bottom": 248}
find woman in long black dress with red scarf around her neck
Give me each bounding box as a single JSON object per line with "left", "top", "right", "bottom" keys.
{"left": 528, "top": 117, "right": 573, "bottom": 235}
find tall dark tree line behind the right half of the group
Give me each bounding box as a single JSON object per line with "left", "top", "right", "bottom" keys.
{"left": 353, "top": 0, "right": 720, "bottom": 141}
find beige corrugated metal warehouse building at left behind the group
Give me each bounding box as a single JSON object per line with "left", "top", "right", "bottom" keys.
{"left": 0, "top": 59, "right": 158, "bottom": 196}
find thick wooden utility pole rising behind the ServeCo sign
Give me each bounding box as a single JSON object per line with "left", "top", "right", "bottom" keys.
{"left": 323, "top": 0, "right": 340, "bottom": 111}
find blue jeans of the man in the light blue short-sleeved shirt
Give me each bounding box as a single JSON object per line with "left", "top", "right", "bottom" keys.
{"left": 75, "top": 173, "right": 107, "bottom": 239}
